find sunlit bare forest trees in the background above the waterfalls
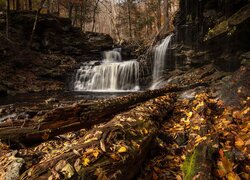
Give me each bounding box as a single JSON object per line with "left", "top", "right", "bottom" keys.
{"left": 0, "top": 0, "right": 179, "bottom": 42}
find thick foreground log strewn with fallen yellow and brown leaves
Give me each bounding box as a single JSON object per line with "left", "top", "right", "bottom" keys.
{"left": 0, "top": 95, "right": 175, "bottom": 180}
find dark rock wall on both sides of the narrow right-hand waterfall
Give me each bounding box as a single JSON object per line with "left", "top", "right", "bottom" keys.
{"left": 140, "top": 0, "right": 250, "bottom": 87}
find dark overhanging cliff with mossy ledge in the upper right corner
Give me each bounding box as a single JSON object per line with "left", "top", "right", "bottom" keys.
{"left": 175, "top": 0, "right": 250, "bottom": 71}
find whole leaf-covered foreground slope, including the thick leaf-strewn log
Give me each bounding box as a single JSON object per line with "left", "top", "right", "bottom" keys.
{"left": 0, "top": 65, "right": 250, "bottom": 180}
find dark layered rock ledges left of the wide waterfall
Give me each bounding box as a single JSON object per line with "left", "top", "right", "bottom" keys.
{"left": 0, "top": 12, "right": 113, "bottom": 95}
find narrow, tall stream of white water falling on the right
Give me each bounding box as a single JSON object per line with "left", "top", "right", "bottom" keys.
{"left": 150, "top": 34, "right": 173, "bottom": 89}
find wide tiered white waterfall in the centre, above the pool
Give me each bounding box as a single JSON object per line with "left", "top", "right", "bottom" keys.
{"left": 74, "top": 49, "right": 139, "bottom": 91}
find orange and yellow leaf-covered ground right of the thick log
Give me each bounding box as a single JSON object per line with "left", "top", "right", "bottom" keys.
{"left": 141, "top": 93, "right": 250, "bottom": 180}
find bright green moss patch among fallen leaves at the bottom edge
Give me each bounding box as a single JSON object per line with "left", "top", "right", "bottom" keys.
{"left": 182, "top": 150, "right": 198, "bottom": 180}
